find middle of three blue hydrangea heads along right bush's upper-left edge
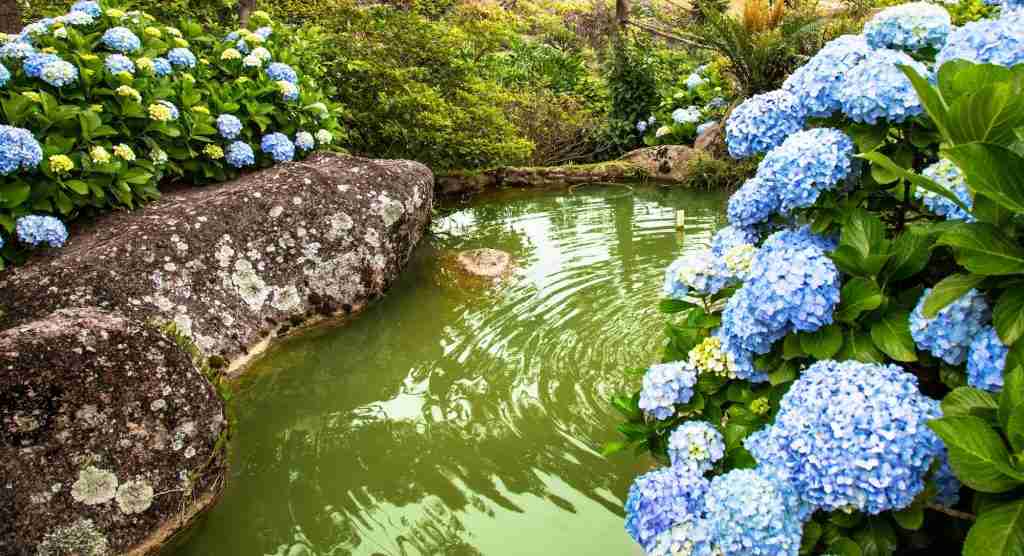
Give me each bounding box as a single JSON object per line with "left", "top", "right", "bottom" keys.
{"left": 782, "top": 35, "right": 871, "bottom": 118}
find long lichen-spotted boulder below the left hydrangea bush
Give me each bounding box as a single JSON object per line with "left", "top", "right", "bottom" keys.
{"left": 0, "top": 154, "right": 433, "bottom": 368}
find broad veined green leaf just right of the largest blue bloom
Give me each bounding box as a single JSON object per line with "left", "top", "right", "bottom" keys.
{"left": 928, "top": 417, "right": 1021, "bottom": 493}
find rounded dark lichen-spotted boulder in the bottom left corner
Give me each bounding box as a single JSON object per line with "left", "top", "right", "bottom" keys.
{"left": 0, "top": 309, "right": 226, "bottom": 555}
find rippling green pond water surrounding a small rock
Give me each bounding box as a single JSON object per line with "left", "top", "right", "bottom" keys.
{"left": 169, "top": 185, "right": 726, "bottom": 556}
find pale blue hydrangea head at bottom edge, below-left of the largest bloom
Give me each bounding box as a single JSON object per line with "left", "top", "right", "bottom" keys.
{"left": 705, "top": 469, "right": 806, "bottom": 556}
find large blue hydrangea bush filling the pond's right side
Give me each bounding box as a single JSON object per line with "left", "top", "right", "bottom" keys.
{"left": 606, "top": 2, "right": 1024, "bottom": 556}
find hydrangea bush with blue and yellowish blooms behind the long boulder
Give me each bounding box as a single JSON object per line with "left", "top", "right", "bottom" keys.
{"left": 0, "top": 1, "right": 341, "bottom": 265}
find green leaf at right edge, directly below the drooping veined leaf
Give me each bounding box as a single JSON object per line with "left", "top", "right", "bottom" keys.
{"left": 936, "top": 222, "right": 1024, "bottom": 275}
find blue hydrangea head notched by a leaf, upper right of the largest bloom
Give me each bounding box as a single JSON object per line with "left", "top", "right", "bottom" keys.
{"left": 910, "top": 288, "right": 991, "bottom": 365}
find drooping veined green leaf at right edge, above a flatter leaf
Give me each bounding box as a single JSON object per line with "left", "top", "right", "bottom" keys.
{"left": 942, "top": 143, "right": 1024, "bottom": 213}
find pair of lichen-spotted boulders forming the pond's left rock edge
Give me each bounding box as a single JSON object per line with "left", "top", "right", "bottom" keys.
{"left": 0, "top": 154, "right": 433, "bottom": 555}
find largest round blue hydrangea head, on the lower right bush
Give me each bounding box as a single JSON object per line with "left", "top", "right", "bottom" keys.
{"left": 743, "top": 359, "right": 944, "bottom": 515}
